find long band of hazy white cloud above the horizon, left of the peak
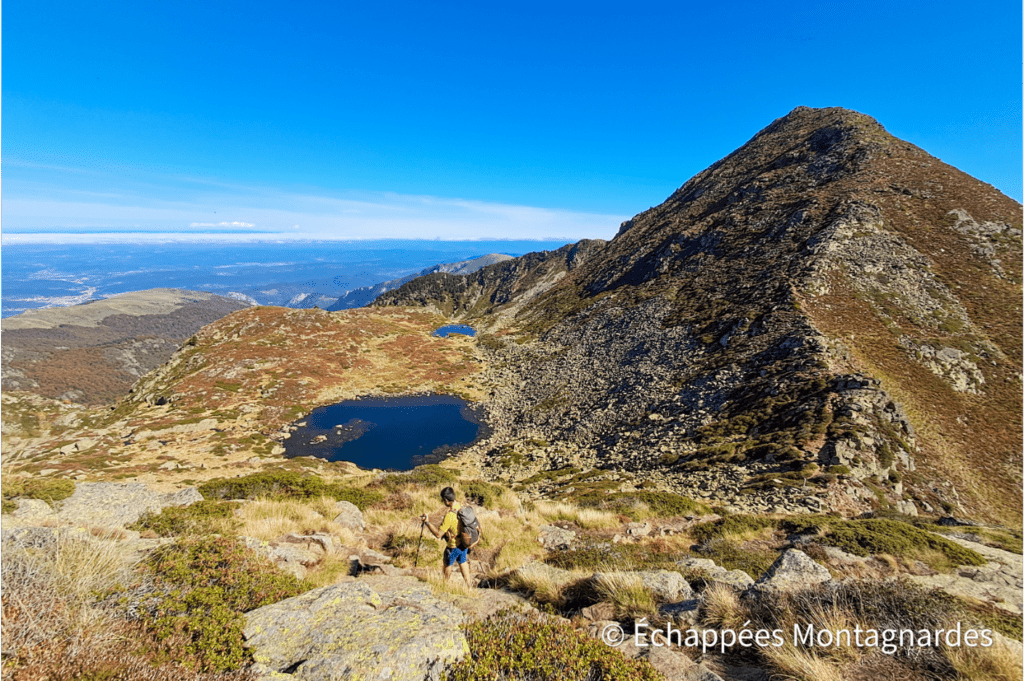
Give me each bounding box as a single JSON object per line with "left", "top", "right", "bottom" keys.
{"left": 4, "top": 184, "right": 626, "bottom": 244}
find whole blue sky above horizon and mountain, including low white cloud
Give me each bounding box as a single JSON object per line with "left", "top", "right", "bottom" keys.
{"left": 2, "top": 0, "right": 1022, "bottom": 243}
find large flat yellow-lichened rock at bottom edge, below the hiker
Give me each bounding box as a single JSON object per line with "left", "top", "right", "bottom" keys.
{"left": 244, "top": 578, "right": 469, "bottom": 681}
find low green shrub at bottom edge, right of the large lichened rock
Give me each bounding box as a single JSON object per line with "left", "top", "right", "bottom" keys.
{"left": 444, "top": 614, "right": 660, "bottom": 681}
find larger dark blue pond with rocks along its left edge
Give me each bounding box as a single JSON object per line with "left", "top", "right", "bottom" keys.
{"left": 284, "top": 395, "right": 483, "bottom": 470}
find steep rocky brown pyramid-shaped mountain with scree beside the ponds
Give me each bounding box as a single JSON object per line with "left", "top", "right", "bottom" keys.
{"left": 378, "top": 107, "right": 1024, "bottom": 521}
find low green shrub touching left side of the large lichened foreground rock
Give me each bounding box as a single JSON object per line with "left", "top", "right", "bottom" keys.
{"left": 146, "top": 537, "right": 303, "bottom": 672}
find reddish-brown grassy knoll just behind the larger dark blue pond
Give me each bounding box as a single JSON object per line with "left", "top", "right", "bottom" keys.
{"left": 124, "top": 307, "right": 477, "bottom": 433}
